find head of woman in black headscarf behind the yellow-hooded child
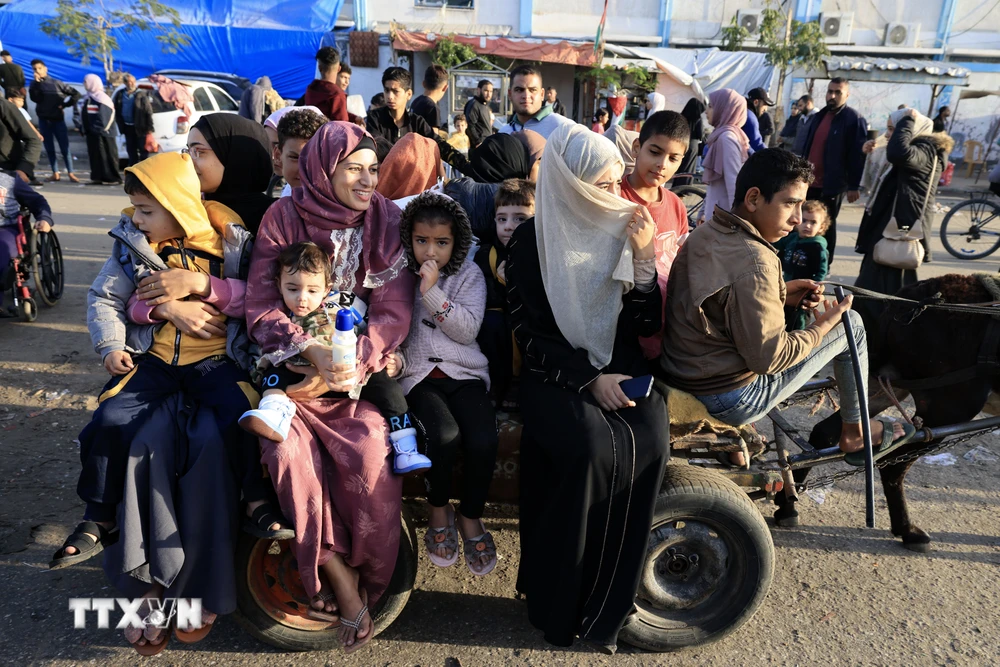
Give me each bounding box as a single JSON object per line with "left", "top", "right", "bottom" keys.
{"left": 188, "top": 113, "right": 274, "bottom": 235}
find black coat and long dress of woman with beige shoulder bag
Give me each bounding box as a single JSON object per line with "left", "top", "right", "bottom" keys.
{"left": 854, "top": 118, "right": 946, "bottom": 321}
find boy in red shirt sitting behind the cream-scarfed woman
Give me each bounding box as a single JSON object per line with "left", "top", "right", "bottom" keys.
{"left": 622, "top": 111, "right": 691, "bottom": 359}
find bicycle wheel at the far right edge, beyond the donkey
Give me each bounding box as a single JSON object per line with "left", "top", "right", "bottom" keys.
{"left": 940, "top": 183, "right": 1000, "bottom": 259}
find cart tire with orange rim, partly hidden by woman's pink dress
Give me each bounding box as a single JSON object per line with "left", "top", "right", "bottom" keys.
{"left": 235, "top": 507, "right": 417, "bottom": 651}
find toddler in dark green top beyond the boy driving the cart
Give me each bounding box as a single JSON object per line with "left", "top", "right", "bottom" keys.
{"left": 774, "top": 199, "right": 830, "bottom": 331}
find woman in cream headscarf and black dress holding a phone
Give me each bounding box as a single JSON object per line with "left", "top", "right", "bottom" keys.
{"left": 506, "top": 125, "right": 669, "bottom": 652}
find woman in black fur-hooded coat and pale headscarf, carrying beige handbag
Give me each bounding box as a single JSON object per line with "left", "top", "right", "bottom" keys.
{"left": 854, "top": 109, "right": 955, "bottom": 315}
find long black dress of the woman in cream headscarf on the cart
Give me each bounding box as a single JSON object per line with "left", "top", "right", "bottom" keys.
{"left": 506, "top": 220, "right": 670, "bottom": 647}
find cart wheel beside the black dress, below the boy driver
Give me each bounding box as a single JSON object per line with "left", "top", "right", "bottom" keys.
{"left": 621, "top": 465, "right": 775, "bottom": 651}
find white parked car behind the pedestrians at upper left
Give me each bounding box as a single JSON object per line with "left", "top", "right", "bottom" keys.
{"left": 115, "top": 79, "right": 239, "bottom": 160}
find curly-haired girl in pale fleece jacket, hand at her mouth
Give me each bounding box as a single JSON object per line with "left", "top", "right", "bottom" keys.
{"left": 390, "top": 192, "right": 498, "bottom": 576}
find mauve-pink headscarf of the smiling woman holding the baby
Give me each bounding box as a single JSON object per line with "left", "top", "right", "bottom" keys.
{"left": 292, "top": 121, "right": 406, "bottom": 287}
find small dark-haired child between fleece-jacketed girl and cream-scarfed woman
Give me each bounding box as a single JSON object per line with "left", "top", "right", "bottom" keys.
{"left": 475, "top": 178, "right": 535, "bottom": 412}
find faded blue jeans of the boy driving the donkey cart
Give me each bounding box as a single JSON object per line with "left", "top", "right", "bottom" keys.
{"left": 698, "top": 310, "right": 868, "bottom": 426}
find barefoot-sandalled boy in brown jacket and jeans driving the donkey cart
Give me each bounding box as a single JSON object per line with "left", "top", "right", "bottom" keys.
{"left": 661, "top": 149, "right": 914, "bottom": 465}
